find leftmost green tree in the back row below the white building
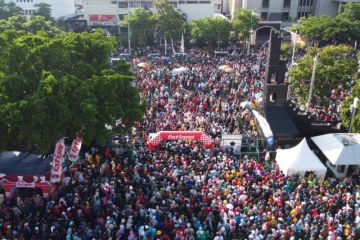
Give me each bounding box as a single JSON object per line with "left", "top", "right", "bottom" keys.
{"left": 121, "top": 8, "right": 155, "bottom": 47}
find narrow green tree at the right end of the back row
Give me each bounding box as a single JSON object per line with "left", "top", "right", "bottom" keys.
{"left": 232, "top": 9, "right": 261, "bottom": 50}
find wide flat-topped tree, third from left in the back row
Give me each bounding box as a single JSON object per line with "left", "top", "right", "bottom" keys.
{"left": 190, "top": 17, "right": 232, "bottom": 50}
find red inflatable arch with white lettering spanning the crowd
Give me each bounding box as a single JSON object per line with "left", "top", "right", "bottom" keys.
{"left": 147, "top": 131, "right": 212, "bottom": 149}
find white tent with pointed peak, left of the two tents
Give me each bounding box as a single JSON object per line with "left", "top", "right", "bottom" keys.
{"left": 276, "top": 138, "right": 327, "bottom": 177}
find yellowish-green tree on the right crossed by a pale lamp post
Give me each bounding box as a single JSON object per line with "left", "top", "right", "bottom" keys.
{"left": 290, "top": 45, "right": 357, "bottom": 105}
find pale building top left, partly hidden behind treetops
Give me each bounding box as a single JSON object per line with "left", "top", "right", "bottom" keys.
{"left": 5, "top": 0, "right": 75, "bottom": 18}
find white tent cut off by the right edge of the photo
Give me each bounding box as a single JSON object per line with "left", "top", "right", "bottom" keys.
{"left": 311, "top": 133, "right": 360, "bottom": 165}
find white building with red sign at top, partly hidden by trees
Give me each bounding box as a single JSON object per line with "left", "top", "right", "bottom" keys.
{"left": 83, "top": 0, "right": 214, "bottom": 26}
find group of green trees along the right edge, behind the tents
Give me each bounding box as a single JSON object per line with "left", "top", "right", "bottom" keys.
{"left": 289, "top": 3, "right": 360, "bottom": 132}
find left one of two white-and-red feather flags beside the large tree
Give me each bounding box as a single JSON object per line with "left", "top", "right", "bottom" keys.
{"left": 50, "top": 138, "right": 65, "bottom": 183}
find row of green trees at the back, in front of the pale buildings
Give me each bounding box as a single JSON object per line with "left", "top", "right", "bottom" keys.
{"left": 121, "top": 0, "right": 260, "bottom": 49}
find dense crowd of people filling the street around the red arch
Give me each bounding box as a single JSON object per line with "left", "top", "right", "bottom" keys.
{"left": 0, "top": 49, "right": 360, "bottom": 240}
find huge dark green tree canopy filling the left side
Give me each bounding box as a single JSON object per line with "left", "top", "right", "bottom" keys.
{"left": 0, "top": 16, "right": 143, "bottom": 153}
